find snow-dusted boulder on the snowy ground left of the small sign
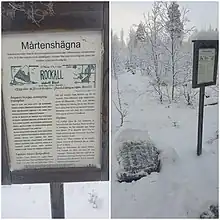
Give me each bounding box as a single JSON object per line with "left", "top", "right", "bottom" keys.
{"left": 116, "top": 141, "right": 160, "bottom": 182}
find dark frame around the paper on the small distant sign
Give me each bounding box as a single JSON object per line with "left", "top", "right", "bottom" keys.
{"left": 192, "top": 40, "right": 218, "bottom": 88}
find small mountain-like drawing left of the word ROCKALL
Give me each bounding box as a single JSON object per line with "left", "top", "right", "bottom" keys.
{"left": 10, "top": 65, "right": 38, "bottom": 86}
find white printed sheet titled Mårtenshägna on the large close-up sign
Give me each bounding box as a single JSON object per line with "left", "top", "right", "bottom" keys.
{"left": 2, "top": 31, "right": 102, "bottom": 170}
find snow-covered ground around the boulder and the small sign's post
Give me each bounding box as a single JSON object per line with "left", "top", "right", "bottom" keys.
{"left": 111, "top": 73, "right": 218, "bottom": 218}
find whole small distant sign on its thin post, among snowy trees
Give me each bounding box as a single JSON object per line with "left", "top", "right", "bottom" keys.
{"left": 192, "top": 40, "right": 218, "bottom": 156}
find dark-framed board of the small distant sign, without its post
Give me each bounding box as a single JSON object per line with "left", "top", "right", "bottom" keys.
{"left": 192, "top": 40, "right": 218, "bottom": 88}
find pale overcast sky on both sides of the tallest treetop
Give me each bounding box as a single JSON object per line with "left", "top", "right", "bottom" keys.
{"left": 111, "top": 1, "right": 218, "bottom": 40}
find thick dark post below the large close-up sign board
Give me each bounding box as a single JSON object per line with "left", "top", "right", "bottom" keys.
{"left": 50, "top": 182, "right": 65, "bottom": 219}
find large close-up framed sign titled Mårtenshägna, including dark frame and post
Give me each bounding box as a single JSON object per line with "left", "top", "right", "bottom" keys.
{"left": 2, "top": 2, "right": 109, "bottom": 217}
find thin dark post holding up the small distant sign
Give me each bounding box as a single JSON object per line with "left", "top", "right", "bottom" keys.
{"left": 197, "top": 86, "right": 205, "bottom": 156}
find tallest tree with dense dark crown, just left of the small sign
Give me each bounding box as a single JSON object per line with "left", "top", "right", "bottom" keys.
{"left": 161, "top": 2, "right": 194, "bottom": 101}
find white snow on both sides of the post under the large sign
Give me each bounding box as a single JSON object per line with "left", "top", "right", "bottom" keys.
{"left": 1, "top": 182, "right": 109, "bottom": 219}
